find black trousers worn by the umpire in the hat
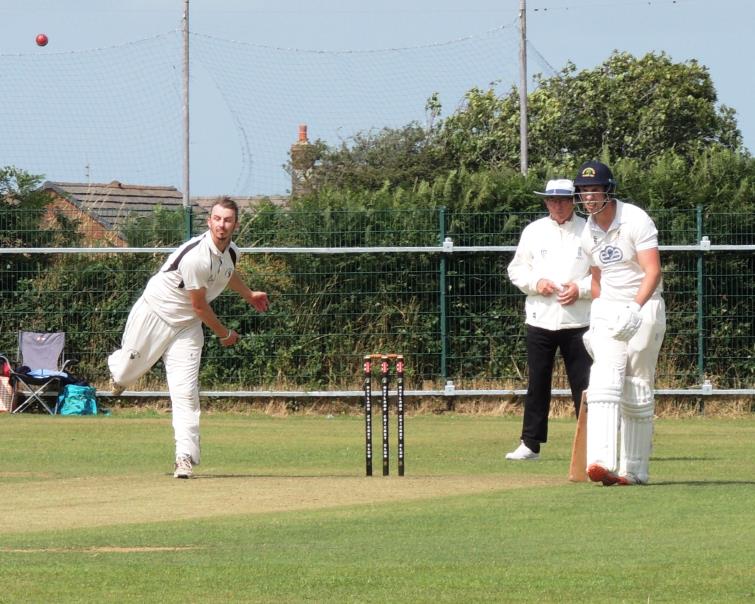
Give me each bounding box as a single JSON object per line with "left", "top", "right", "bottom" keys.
{"left": 522, "top": 325, "right": 592, "bottom": 453}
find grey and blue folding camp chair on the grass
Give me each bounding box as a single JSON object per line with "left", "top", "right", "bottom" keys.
{"left": 10, "top": 331, "right": 76, "bottom": 415}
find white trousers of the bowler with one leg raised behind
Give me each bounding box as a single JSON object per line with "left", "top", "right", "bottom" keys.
{"left": 108, "top": 298, "right": 204, "bottom": 465}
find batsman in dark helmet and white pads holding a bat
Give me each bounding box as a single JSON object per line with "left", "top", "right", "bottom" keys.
{"left": 574, "top": 161, "right": 666, "bottom": 486}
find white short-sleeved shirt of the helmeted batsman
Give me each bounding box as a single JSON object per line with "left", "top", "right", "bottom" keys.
{"left": 582, "top": 199, "right": 663, "bottom": 302}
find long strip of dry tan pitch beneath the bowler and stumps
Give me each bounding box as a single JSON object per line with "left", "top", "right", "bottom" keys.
{"left": 0, "top": 474, "right": 563, "bottom": 534}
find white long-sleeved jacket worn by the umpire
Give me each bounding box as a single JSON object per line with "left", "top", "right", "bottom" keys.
{"left": 508, "top": 214, "right": 591, "bottom": 331}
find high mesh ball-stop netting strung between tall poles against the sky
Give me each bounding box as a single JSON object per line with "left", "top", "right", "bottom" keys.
{"left": 0, "top": 24, "right": 547, "bottom": 195}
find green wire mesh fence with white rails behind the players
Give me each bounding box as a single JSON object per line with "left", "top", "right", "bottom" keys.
{"left": 0, "top": 206, "right": 755, "bottom": 393}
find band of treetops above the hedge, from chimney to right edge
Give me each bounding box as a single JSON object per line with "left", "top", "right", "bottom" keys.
{"left": 302, "top": 52, "right": 743, "bottom": 198}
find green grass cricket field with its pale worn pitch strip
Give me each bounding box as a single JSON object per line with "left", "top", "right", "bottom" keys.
{"left": 0, "top": 412, "right": 755, "bottom": 604}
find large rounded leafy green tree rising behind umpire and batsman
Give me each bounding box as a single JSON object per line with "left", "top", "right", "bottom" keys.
{"left": 439, "top": 52, "right": 743, "bottom": 170}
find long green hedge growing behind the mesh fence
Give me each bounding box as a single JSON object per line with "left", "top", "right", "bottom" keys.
{"left": 0, "top": 146, "right": 755, "bottom": 390}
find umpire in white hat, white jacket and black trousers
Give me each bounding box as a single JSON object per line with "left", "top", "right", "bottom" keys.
{"left": 506, "top": 179, "right": 592, "bottom": 461}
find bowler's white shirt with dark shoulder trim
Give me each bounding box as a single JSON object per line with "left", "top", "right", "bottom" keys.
{"left": 142, "top": 231, "right": 239, "bottom": 327}
